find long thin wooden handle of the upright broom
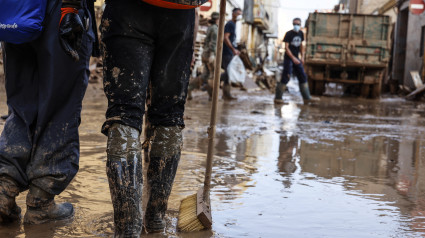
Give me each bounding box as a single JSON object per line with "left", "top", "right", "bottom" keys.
{"left": 203, "top": 0, "right": 226, "bottom": 201}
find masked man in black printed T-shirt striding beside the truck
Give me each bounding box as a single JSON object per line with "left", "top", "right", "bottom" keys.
{"left": 274, "top": 18, "right": 319, "bottom": 104}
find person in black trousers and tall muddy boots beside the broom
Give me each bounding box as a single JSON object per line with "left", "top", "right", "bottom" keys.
{"left": 101, "top": 0, "right": 205, "bottom": 237}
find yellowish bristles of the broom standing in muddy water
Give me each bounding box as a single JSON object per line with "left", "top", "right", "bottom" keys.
{"left": 177, "top": 194, "right": 205, "bottom": 232}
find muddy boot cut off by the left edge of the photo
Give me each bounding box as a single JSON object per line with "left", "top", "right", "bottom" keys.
{"left": 0, "top": 176, "right": 21, "bottom": 223}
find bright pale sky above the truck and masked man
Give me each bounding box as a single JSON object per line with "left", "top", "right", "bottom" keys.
{"left": 276, "top": 0, "right": 339, "bottom": 38}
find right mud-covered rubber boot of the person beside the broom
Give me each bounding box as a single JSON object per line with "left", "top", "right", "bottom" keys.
{"left": 145, "top": 126, "right": 183, "bottom": 233}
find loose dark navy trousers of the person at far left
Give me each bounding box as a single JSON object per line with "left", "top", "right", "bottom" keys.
{"left": 0, "top": 0, "right": 94, "bottom": 195}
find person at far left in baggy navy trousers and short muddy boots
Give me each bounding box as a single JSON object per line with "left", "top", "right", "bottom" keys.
{"left": 0, "top": 0, "right": 98, "bottom": 224}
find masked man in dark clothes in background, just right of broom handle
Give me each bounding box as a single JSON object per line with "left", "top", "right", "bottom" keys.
{"left": 220, "top": 8, "right": 242, "bottom": 100}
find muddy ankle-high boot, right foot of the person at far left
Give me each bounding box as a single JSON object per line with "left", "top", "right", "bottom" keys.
{"left": 24, "top": 185, "right": 74, "bottom": 224}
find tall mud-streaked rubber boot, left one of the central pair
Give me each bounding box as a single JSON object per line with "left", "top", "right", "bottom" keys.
{"left": 106, "top": 124, "right": 143, "bottom": 238}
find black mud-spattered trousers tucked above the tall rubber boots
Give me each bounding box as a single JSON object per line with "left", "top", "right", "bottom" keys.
{"left": 102, "top": 0, "right": 195, "bottom": 134}
